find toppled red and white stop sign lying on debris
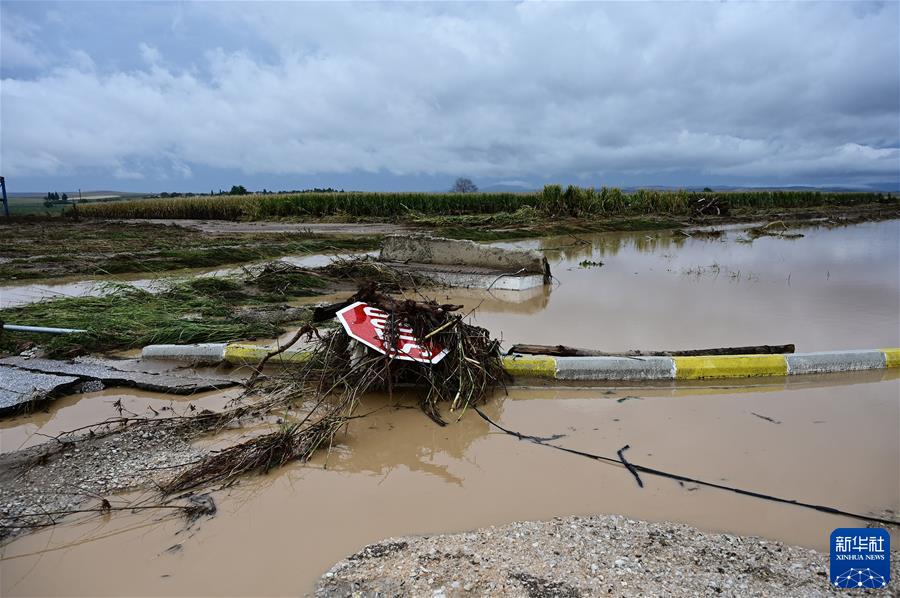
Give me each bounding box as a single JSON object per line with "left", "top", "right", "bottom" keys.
{"left": 337, "top": 301, "right": 447, "bottom": 363}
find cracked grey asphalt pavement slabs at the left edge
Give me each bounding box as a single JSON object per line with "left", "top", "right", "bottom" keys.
{"left": 0, "top": 357, "right": 241, "bottom": 412}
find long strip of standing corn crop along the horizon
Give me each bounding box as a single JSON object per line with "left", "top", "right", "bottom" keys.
{"left": 78, "top": 185, "right": 897, "bottom": 220}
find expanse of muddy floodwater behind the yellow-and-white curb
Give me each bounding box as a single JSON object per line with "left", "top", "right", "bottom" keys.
{"left": 460, "top": 220, "right": 900, "bottom": 351}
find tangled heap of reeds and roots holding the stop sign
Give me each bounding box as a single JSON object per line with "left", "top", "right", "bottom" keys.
{"left": 154, "top": 284, "right": 506, "bottom": 494}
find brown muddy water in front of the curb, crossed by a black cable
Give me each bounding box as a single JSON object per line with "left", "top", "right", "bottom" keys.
{"left": 0, "top": 372, "right": 900, "bottom": 596}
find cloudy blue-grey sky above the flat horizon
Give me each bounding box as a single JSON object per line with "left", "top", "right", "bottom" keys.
{"left": 0, "top": 0, "right": 900, "bottom": 191}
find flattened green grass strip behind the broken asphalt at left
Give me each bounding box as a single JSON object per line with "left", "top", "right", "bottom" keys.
{"left": 0, "top": 270, "right": 326, "bottom": 358}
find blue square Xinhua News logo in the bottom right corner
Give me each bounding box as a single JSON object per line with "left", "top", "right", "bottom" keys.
{"left": 830, "top": 527, "right": 891, "bottom": 588}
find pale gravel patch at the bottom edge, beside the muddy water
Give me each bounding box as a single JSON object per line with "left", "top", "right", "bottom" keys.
{"left": 315, "top": 515, "right": 900, "bottom": 598}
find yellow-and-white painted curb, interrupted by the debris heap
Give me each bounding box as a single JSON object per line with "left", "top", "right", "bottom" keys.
{"left": 142, "top": 343, "right": 900, "bottom": 381}
